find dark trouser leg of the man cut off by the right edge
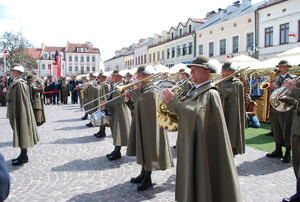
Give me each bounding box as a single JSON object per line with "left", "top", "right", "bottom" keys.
{"left": 291, "top": 135, "right": 300, "bottom": 182}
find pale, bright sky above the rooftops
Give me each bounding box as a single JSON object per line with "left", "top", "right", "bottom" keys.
{"left": 0, "top": 0, "right": 262, "bottom": 62}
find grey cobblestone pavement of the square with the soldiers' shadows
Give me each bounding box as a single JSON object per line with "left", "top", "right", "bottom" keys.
{"left": 0, "top": 104, "right": 296, "bottom": 202}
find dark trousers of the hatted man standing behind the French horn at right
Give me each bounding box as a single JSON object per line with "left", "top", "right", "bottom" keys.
{"left": 271, "top": 109, "right": 293, "bottom": 147}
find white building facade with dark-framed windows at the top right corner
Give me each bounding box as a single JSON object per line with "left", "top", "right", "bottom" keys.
{"left": 256, "top": 0, "right": 300, "bottom": 60}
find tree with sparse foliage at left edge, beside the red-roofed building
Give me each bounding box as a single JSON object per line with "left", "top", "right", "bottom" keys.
{"left": 0, "top": 32, "right": 38, "bottom": 70}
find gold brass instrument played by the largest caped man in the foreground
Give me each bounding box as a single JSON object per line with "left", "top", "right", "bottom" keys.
{"left": 156, "top": 67, "right": 250, "bottom": 131}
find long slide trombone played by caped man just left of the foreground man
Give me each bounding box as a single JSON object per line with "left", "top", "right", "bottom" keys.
{"left": 81, "top": 72, "right": 163, "bottom": 113}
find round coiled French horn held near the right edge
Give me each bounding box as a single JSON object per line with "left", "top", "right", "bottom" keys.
{"left": 270, "top": 77, "right": 300, "bottom": 112}
